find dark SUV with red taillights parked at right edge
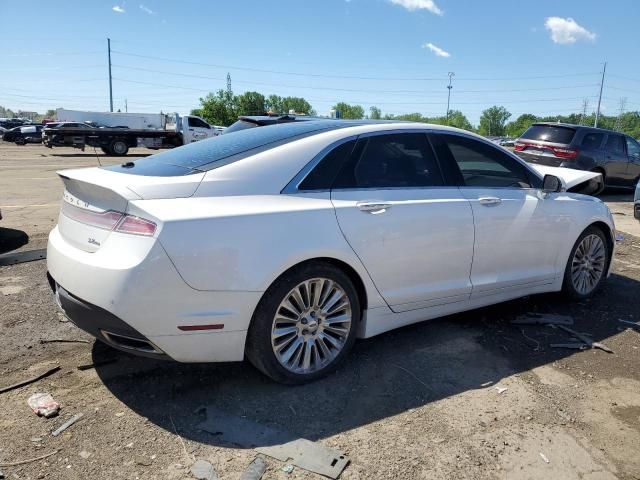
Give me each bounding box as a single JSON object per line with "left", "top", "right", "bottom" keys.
{"left": 515, "top": 123, "right": 640, "bottom": 188}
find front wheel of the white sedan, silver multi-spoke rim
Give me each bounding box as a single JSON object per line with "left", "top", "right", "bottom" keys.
{"left": 562, "top": 226, "right": 611, "bottom": 300}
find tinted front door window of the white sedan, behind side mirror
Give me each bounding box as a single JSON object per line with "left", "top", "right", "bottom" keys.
{"left": 434, "top": 134, "right": 540, "bottom": 188}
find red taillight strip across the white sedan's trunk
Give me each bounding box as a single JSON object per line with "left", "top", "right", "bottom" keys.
{"left": 61, "top": 201, "right": 157, "bottom": 237}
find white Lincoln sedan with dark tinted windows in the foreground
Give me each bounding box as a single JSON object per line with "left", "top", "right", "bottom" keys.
{"left": 47, "top": 120, "right": 614, "bottom": 383}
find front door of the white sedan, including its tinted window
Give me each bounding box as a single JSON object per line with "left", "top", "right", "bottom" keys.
{"left": 431, "top": 133, "right": 569, "bottom": 299}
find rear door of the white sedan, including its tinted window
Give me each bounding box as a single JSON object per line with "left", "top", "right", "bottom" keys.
{"left": 331, "top": 130, "right": 473, "bottom": 312}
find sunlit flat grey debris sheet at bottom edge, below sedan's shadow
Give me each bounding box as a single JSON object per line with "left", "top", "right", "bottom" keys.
{"left": 256, "top": 438, "right": 349, "bottom": 478}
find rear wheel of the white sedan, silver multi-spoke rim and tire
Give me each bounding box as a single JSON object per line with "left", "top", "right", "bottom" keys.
{"left": 246, "top": 262, "right": 361, "bottom": 384}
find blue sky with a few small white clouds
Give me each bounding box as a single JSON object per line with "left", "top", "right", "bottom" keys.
{"left": 0, "top": 0, "right": 640, "bottom": 124}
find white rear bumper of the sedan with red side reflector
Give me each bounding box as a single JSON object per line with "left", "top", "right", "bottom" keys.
{"left": 47, "top": 227, "right": 261, "bottom": 362}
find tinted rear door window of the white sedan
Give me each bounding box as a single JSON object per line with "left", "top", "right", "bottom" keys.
{"left": 334, "top": 133, "right": 443, "bottom": 189}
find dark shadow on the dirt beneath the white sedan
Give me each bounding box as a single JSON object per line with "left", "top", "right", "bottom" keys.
{"left": 93, "top": 275, "right": 640, "bottom": 447}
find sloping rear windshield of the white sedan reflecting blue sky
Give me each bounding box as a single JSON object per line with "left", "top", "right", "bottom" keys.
{"left": 103, "top": 121, "right": 349, "bottom": 176}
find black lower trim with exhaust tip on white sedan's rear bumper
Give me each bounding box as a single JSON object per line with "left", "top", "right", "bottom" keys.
{"left": 47, "top": 273, "right": 169, "bottom": 359}
